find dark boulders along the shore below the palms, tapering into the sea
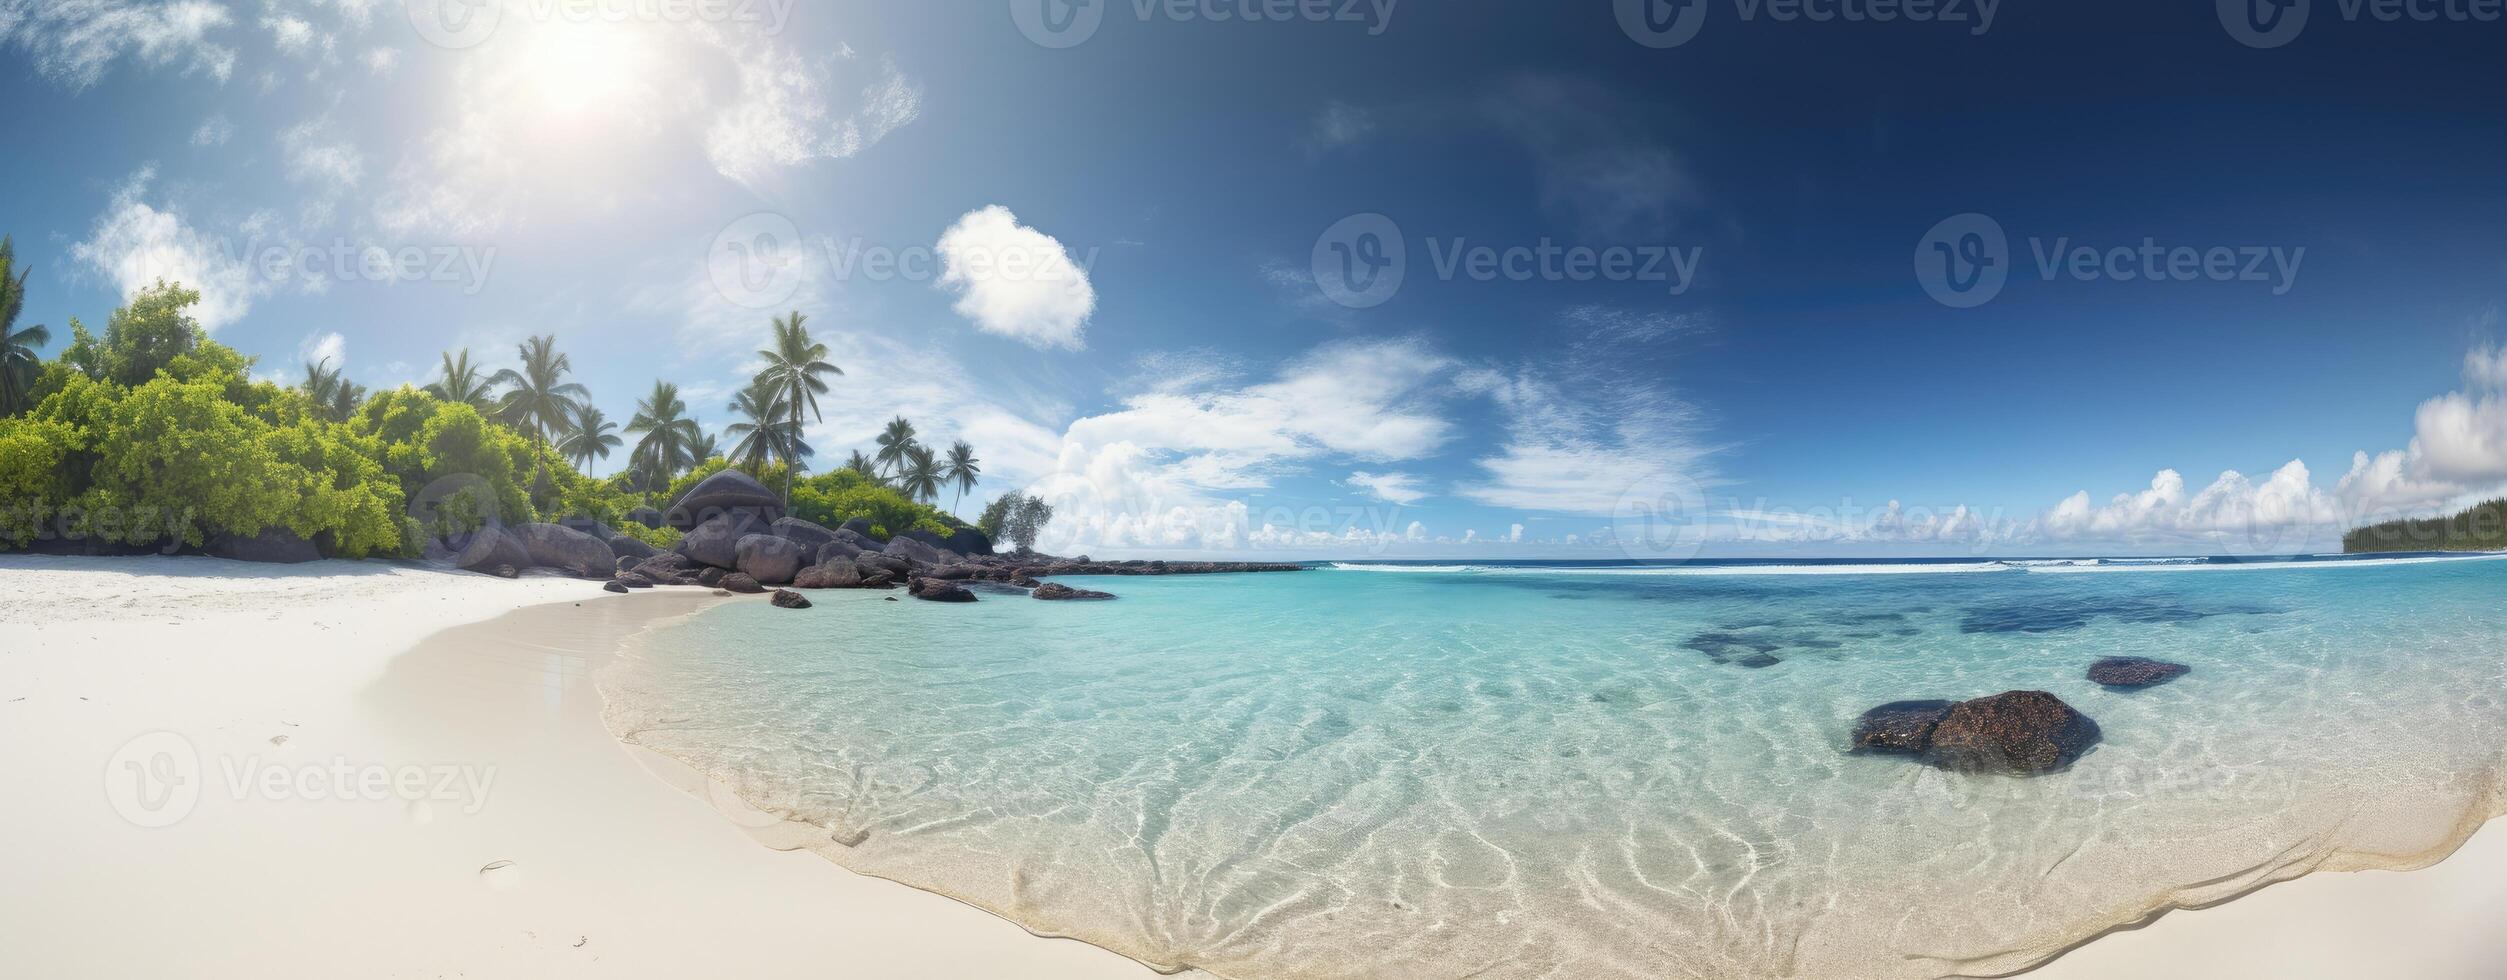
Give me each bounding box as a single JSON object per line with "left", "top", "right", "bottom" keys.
{"left": 612, "top": 471, "right": 1299, "bottom": 602}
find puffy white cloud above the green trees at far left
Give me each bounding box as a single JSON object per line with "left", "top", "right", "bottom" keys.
{"left": 70, "top": 165, "right": 268, "bottom": 331}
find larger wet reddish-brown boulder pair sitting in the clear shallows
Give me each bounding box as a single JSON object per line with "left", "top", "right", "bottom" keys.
{"left": 1853, "top": 692, "right": 2098, "bottom": 777}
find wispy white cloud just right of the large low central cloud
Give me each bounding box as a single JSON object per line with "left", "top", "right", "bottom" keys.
{"left": 1457, "top": 308, "right": 1715, "bottom": 519}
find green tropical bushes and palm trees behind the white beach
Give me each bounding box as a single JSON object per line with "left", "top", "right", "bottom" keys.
{"left": 0, "top": 249, "right": 1050, "bottom": 556}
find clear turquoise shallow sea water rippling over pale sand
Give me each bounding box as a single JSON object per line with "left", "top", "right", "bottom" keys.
{"left": 602, "top": 559, "right": 2507, "bottom": 977}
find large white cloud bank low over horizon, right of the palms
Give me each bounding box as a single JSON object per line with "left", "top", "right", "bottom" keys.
{"left": 1030, "top": 341, "right": 1454, "bottom": 551}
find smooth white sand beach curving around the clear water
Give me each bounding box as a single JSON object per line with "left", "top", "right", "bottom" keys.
{"left": 0, "top": 556, "right": 2507, "bottom": 980}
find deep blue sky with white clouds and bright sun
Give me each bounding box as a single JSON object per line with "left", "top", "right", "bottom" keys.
{"left": 0, "top": 0, "right": 2507, "bottom": 556}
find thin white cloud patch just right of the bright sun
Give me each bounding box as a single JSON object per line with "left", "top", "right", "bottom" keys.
{"left": 704, "top": 38, "right": 923, "bottom": 183}
